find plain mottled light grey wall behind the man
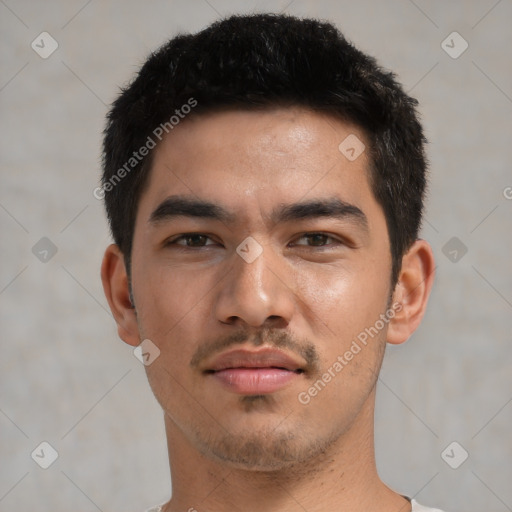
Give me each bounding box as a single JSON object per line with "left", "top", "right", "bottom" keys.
{"left": 0, "top": 0, "right": 512, "bottom": 512}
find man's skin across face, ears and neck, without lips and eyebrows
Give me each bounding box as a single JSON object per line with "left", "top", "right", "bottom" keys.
{"left": 102, "top": 108, "right": 434, "bottom": 512}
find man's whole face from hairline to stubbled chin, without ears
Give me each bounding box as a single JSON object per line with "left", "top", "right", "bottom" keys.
{"left": 127, "top": 108, "right": 392, "bottom": 469}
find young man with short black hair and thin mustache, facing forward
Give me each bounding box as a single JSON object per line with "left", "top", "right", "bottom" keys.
{"left": 100, "top": 15, "right": 440, "bottom": 512}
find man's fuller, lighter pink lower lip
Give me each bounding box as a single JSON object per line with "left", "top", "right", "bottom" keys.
{"left": 212, "top": 368, "right": 299, "bottom": 395}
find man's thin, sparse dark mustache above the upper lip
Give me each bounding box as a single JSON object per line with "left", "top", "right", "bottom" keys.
{"left": 190, "top": 327, "right": 320, "bottom": 374}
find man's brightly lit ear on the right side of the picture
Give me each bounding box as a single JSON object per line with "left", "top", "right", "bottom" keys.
{"left": 387, "top": 240, "right": 435, "bottom": 344}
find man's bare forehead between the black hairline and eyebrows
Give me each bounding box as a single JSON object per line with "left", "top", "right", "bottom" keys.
{"left": 140, "top": 107, "right": 373, "bottom": 221}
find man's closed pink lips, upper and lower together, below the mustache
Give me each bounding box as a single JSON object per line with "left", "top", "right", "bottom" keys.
{"left": 204, "top": 348, "right": 304, "bottom": 395}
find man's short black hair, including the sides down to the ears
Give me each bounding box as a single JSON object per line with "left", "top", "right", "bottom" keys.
{"left": 100, "top": 14, "right": 427, "bottom": 286}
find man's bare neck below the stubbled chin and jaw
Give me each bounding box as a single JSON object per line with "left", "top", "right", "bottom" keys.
{"left": 163, "top": 390, "right": 411, "bottom": 512}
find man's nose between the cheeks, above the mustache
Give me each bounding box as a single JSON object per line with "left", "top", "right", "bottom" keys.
{"left": 214, "top": 240, "right": 296, "bottom": 327}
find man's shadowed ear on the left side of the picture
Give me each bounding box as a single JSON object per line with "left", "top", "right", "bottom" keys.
{"left": 101, "top": 244, "right": 140, "bottom": 347}
